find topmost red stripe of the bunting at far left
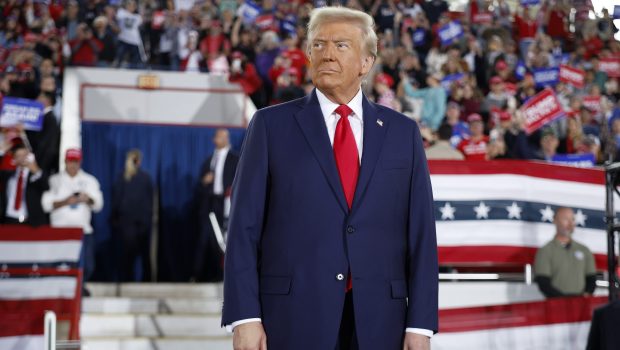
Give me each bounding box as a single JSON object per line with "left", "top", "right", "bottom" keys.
{"left": 0, "top": 225, "right": 83, "bottom": 241}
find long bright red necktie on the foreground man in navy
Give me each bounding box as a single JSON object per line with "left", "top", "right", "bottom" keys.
{"left": 334, "top": 105, "right": 360, "bottom": 292}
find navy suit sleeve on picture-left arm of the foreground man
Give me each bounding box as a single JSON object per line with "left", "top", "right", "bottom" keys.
{"left": 222, "top": 112, "right": 269, "bottom": 326}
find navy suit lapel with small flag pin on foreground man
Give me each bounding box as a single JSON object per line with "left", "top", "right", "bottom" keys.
{"left": 352, "top": 96, "right": 388, "bottom": 210}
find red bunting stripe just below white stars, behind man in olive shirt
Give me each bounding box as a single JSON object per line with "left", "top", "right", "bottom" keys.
{"left": 437, "top": 245, "right": 607, "bottom": 270}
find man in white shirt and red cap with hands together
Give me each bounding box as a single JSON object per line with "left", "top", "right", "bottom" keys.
{"left": 41, "top": 148, "right": 103, "bottom": 290}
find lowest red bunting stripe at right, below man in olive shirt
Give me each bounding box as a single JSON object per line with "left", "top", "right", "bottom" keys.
{"left": 439, "top": 297, "right": 607, "bottom": 333}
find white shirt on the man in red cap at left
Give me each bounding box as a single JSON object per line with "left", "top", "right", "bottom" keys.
{"left": 41, "top": 170, "right": 103, "bottom": 234}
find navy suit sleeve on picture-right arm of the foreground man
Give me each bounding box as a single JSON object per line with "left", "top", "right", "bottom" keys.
{"left": 407, "top": 122, "right": 439, "bottom": 333}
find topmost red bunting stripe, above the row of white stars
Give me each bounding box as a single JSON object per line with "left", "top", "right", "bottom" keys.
{"left": 428, "top": 160, "right": 605, "bottom": 185}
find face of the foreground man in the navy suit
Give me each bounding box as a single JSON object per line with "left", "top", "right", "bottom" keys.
{"left": 309, "top": 22, "right": 373, "bottom": 103}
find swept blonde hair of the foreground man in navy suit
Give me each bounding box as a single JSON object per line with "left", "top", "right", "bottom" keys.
{"left": 308, "top": 6, "right": 378, "bottom": 58}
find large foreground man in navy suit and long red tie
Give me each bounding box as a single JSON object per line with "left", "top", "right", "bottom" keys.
{"left": 222, "top": 7, "right": 438, "bottom": 350}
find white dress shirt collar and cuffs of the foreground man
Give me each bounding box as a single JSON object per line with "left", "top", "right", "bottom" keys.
{"left": 226, "top": 89, "right": 433, "bottom": 338}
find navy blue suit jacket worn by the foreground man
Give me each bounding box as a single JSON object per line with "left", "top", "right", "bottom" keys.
{"left": 222, "top": 92, "right": 438, "bottom": 350}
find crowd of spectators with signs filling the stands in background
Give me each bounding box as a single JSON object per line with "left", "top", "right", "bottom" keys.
{"left": 0, "top": 0, "right": 620, "bottom": 165}
